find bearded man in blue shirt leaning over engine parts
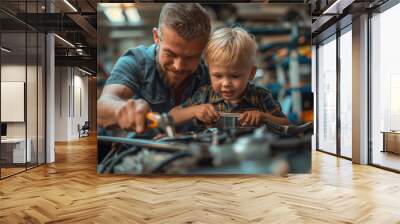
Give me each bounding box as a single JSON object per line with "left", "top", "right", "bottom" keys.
{"left": 98, "top": 3, "right": 211, "bottom": 133}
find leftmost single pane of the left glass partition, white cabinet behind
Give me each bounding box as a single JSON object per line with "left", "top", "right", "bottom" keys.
{"left": 0, "top": 32, "right": 30, "bottom": 177}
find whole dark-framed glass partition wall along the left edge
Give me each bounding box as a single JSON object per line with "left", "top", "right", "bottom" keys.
{"left": 0, "top": 1, "right": 46, "bottom": 179}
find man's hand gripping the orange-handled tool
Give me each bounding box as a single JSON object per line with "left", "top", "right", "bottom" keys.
{"left": 115, "top": 99, "right": 150, "bottom": 133}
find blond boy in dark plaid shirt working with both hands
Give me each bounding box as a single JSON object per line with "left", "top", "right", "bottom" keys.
{"left": 170, "top": 27, "right": 288, "bottom": 126}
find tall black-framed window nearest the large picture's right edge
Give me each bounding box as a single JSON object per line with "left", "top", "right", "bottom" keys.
{"left": 316, "top": 25, "right": 352, "bottom": 159}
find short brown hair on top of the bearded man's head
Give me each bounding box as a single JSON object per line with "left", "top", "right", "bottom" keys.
{"left": 158, "top": 3, "right": 211, "bottom": 40}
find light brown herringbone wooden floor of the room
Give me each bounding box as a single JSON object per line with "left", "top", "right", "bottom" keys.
{"left": 0, "top": 137, "right": 400, "bottom": 224}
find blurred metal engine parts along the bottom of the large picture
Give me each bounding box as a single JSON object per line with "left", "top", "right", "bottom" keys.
{"left": 98, "top": 121, "right": 312, "bottom": 175}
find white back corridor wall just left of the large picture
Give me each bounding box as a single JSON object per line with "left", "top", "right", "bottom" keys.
{"left": 55, "top": 67, "right": 88, "bottom": 141}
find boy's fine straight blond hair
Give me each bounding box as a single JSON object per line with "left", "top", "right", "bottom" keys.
{"left": 204, "top": 27, "right": 257, "bottom": 66}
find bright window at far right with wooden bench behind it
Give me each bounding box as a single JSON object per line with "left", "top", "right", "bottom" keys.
{"left": 370, "top": 3, "right": 400, "bottom": 172}
